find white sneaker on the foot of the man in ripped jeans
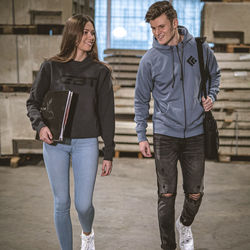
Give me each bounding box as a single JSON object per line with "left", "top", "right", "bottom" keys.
{"left": 176, "top": 217, "right": 194, "bottom": 250}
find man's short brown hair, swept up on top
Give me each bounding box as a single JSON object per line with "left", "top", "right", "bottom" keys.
{"left": 145, "top": 1, "right": 177, "bottom": 23}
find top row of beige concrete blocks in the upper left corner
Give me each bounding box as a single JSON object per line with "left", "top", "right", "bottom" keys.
{"left": 0, "top": 0, "right": 72, "bottom": 24}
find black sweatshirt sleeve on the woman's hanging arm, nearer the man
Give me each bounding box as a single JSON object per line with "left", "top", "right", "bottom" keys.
{"left": 98, "top": 69, "right": 115, "bottom": 161}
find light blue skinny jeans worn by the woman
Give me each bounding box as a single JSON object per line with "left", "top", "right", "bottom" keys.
{"left": 43, "top": 138, "right": 99, "bottom": 250}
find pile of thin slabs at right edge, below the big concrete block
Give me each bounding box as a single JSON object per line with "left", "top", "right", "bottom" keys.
{"left": 214, "top": 53, "right": 250, "bottom": 161}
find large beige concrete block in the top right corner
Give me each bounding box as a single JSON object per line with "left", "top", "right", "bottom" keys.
{"left": 202, "top": 2, "right": 250, "bottom": 44}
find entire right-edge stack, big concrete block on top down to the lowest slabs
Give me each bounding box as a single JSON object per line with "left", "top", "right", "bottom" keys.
{"left": 201, "top": 0, "right": 250, "bottom": 160}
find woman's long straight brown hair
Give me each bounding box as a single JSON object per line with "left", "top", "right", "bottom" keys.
{"left": 50, "top": 14, "right": 99, "bottom": 62}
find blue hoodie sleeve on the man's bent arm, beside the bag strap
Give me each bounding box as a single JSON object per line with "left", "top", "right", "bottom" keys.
{"left": 205, "top": 43, "right": 221, "bottom": 102}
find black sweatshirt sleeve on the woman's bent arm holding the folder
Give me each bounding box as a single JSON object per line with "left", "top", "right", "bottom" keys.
{"left": 26, "top": 61, "right": 50, "bottom": 133}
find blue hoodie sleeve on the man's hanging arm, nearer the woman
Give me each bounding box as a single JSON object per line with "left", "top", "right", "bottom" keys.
{"left": 134, "top": 58, "right": 153, "bottom": 142}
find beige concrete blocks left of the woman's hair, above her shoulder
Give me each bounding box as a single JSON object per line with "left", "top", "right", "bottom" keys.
{"left": 0, "top": 35, "right": 61, "bottom": 83}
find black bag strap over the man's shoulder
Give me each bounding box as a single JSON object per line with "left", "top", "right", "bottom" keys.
{"left": 195, "top": 37, "right": 207, "bottom": 98}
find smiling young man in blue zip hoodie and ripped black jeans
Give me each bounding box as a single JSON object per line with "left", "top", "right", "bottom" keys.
{"left": 135, "top": 1, "right": 220, "bottom": 250}
